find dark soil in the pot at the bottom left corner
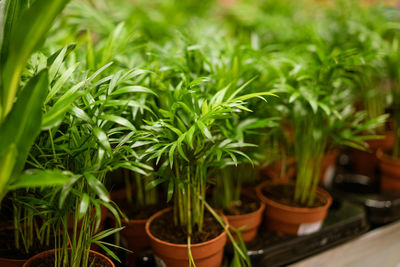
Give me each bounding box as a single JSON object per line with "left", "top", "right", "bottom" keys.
{"left": 0, "top": 228, "right": 54, "bottom": 260}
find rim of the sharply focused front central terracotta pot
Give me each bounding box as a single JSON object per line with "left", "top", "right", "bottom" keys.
{"left": 145, "top": 207, "right": 228, "bottom": 248}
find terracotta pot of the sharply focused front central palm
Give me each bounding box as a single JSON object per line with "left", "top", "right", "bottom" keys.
{"left": 146, "top": 208, "right": 227, "bottom": 267}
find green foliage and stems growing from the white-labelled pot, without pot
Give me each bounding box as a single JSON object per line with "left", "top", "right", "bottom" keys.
{"left": 277, "top": 46, "right": 387, "bottom": 206}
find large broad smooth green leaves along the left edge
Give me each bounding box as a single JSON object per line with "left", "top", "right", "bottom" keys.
{"left": 0, "top": 0, "right": 76, "bottom": 266}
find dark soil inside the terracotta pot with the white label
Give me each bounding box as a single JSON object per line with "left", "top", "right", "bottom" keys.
{"left": 262, "top": 184, "right": 327, "bottom": 208}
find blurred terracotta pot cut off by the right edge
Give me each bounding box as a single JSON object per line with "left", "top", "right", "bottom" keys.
{"left": 376, "top": 149, "right": 400, "bottom": 191}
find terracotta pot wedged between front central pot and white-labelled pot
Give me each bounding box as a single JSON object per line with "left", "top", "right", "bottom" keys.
{"left": 225, "top": 202, "right": 265, "bottom": 242}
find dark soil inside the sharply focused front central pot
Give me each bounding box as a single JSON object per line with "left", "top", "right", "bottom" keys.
{"left": 150, "top": 210, "right": 223, "bottom": 244}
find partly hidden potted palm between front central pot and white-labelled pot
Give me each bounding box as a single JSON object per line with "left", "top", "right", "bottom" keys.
{"left": 211, "top": 114, "right": 277, "bottom": 242}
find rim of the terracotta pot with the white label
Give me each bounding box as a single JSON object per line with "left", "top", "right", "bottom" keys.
{"left": 256, "top": 181, "right": 332, "bottom": 213}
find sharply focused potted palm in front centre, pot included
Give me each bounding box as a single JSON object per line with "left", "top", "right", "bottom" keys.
{"left": 139, "top": 75, "right": 270, "bottom": 266}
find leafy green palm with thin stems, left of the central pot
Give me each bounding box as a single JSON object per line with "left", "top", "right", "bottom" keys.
{"left": 21, "top": 59, "right": 155, "bottom": 266}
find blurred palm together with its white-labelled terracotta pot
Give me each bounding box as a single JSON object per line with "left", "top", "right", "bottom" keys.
{"left": 257, "top": 46, "right": 384, "bottom": 235}
